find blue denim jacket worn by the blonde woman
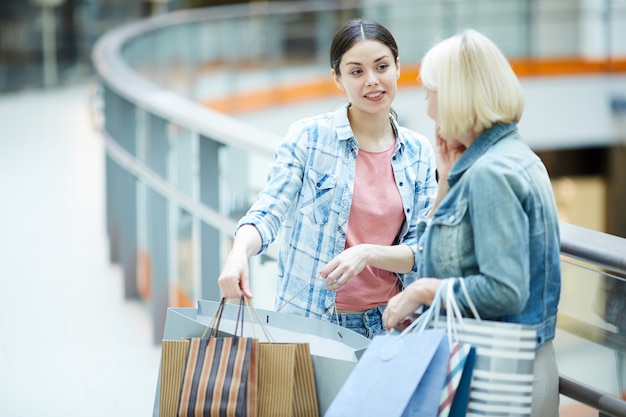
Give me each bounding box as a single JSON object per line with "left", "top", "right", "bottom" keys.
{"left": 416, "top": 123, "right": 561, "bottom": 349}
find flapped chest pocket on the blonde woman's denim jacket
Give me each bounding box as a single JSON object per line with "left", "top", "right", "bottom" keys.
{"left": 430, "top": 201, "right": 474, "bottom": 276}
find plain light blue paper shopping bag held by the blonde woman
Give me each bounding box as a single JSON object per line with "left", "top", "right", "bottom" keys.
{"left": 325, "top": 329, "right": 450, "bottom": 417}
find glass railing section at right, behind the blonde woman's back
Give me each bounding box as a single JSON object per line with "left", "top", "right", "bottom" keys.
{"left": 554, "top": 223, "right": 626, "bottom": 416}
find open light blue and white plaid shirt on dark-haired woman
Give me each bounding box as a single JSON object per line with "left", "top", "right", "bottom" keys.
{"left": 237, "top": 105, "right": 437, "bottom": 321}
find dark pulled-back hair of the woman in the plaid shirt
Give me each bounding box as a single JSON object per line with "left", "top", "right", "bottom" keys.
{"left": 330, "top": 18, "right": 398, "bottom": 75}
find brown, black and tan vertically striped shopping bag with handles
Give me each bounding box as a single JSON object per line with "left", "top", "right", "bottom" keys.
{"left": 177, "top": 299, "right": 258, "bottom": 417}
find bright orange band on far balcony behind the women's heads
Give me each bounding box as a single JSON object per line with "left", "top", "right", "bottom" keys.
{"left": 200, "top": 57, "right": 626, "bottom": 114}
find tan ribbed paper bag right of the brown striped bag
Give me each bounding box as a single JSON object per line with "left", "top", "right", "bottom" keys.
{"left": 258, "top": 342, "right": 319, "bottom": 417}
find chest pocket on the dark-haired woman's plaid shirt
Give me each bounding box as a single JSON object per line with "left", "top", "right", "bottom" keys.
{"left": 300, "top": 168, "right": 337, "bottom": 224}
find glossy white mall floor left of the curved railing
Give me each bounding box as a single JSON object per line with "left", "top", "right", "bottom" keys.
{"left": 0, "top": 83, "right": 160, "bottom": 417}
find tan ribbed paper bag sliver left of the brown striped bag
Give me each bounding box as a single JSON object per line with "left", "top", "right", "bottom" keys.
{"left": 159, "top": 339, "right": 189, "bottom": 417}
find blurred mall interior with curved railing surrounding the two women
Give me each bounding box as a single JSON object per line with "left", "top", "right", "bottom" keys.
{"left": 0, "top": 0, "right": 626, "bottom": 417}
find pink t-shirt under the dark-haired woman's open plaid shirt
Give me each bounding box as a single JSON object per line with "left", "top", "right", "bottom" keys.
{"left": 337, "top": 144, "right": 404, "bottom": 311}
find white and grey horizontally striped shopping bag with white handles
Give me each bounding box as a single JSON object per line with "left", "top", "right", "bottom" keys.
{"left": 446, "top": 279, "right": 537, "bottom": 417}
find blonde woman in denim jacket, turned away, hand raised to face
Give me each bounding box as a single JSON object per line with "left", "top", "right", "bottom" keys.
{"left": 383, "top": 30, "right": 561, "bottom": 417}
